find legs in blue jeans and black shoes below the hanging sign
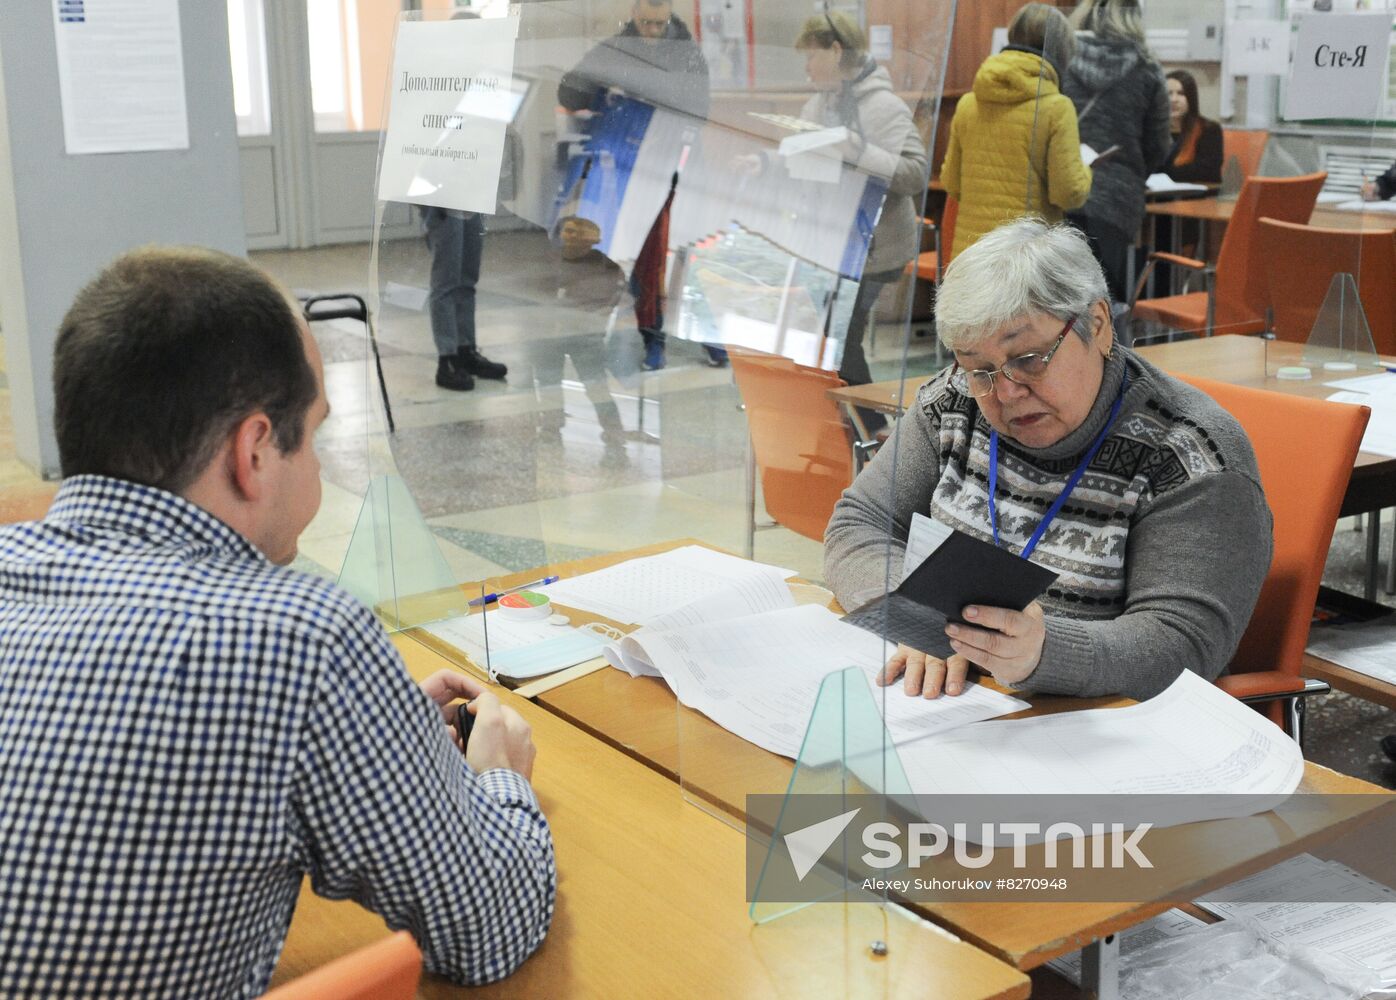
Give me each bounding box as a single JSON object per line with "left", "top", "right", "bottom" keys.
{"left": 422, "top": 205, "right": 510, "bottom": 392}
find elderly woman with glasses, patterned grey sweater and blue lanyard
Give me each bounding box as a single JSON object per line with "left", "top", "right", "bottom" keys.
{"left": 825, "top": 219, "right": 1272, "bottom": 698}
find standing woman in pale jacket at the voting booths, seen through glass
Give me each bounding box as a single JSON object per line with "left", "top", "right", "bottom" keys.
{"left": 794, "top": 11, "right": 927, "bottom": 432}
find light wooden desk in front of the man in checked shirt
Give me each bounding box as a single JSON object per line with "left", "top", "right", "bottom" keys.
{"left": 272, "top": 638, "right": 1029, "bottom": 1000}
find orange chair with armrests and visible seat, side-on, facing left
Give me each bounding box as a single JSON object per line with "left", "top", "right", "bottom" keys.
{"left": 1134, "top": 173, "right": 1328, "bottom": 337}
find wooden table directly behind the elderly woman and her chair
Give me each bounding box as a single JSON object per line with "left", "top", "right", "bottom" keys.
{"left": 828, "top": 339, "right": 1396, "bottom": 601}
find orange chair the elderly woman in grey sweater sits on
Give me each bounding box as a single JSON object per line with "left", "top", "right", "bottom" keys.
{"left": 1184, "top": 377, "right": 1371, "bottom": 740}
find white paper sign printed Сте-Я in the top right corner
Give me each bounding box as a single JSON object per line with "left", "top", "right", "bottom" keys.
{"left": 1284, "top": 11, "right": 1392, "bottom": 122}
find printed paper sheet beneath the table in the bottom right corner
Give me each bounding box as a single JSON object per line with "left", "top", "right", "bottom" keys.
{"left": 1198, "top": 855, "right": 1396, "bottom": 986}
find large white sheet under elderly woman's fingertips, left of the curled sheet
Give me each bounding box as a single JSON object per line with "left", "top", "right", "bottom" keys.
{"left": 607, "top": 605, "right": 1027, "bottom": 757}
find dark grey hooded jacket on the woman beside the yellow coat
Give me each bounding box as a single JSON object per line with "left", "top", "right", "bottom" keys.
{"left": 1061, "top": 31, "right": 1173, "bottom": 239}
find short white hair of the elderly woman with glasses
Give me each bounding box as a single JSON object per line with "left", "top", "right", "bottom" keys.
{"left": 935, "top": 218, "right": 1110, "bottom": 351}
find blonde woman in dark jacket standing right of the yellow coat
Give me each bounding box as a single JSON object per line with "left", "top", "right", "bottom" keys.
{"left": 1062, "top": 0, "right": 1171, "bottom": 302}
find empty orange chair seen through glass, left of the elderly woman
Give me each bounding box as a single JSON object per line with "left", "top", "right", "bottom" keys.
{"left": 729, "top": 348, "right": 853, "bottom": 542}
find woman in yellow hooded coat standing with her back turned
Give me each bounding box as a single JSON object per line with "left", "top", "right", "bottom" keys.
{"left": 941, "top": 3, "right": 1090, "bottom": 254}
